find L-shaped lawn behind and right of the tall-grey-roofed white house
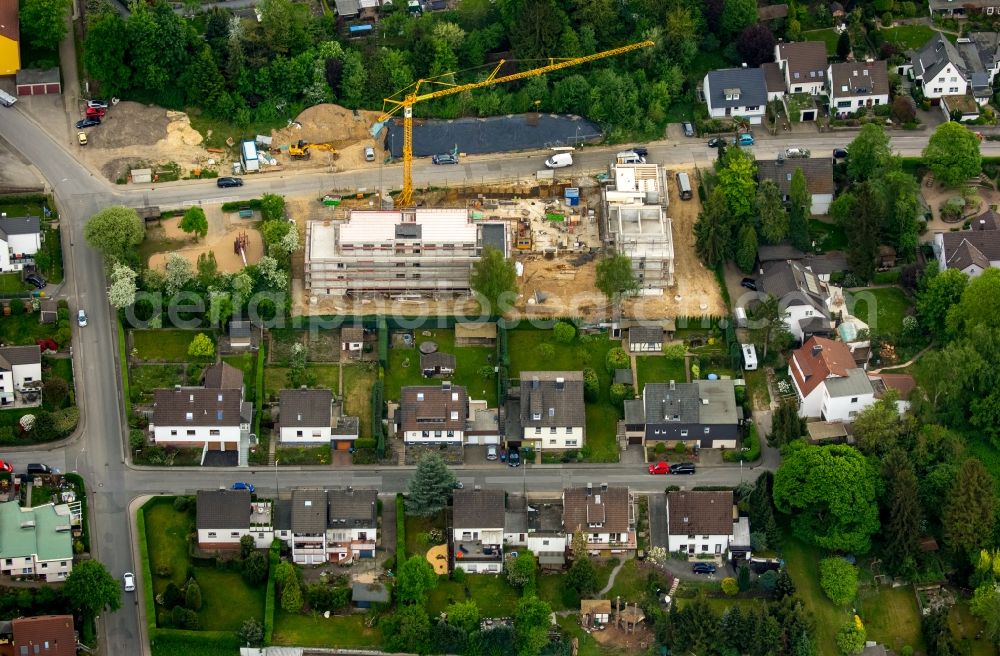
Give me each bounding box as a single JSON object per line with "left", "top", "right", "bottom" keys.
{"left": 507, "top": 329, "right": 621, "bottom": 462}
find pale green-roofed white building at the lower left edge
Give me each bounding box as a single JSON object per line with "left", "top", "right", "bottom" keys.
{"left": 0, "top": 501, "right": 73, "bottom": 583}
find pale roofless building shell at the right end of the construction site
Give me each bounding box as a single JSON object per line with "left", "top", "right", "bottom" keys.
{"left": 604, "top": 164, "right": 674, "bottom": 293}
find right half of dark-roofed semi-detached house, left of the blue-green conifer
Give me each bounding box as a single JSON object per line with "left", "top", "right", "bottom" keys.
{"left": 326, "top": 487, "right": 378, "bottom": 563}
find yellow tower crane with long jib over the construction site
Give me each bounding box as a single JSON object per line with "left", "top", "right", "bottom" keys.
{"left": 378, "top": 41, "right": 655, "bottom": 207}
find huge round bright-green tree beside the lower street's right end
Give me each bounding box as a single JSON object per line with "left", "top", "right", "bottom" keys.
{"left": 774, "top": 444, "right": 879, "bottom": 554}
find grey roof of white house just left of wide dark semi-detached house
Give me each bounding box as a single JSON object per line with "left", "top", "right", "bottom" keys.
{"left": 521, "top": 371, "right": 587, "bottom": 427}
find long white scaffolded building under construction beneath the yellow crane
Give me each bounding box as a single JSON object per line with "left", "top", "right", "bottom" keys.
{"left": 305, "top": 208, "right": 509, "bottom": 297}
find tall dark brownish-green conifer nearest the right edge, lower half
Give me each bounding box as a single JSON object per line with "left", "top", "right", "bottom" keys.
{"left": 941, "top": 458, "right": 997, "bottom": 554}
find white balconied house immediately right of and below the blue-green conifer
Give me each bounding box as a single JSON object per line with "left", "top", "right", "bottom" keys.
{"left": 451, "top": 488, "right": 506, "bottom": 574}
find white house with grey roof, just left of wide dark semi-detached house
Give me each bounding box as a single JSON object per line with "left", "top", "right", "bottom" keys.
{"left": 520, "top": 371, "right": 587, "bottom": 451}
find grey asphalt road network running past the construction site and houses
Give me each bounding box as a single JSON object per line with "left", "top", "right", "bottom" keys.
{"left": 0, "top": 100, "right": 968, "bottom": 655}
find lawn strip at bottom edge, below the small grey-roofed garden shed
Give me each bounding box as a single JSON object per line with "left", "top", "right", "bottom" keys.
{"left": 273, "top": 606, "right": 382, "bottom": 649}
